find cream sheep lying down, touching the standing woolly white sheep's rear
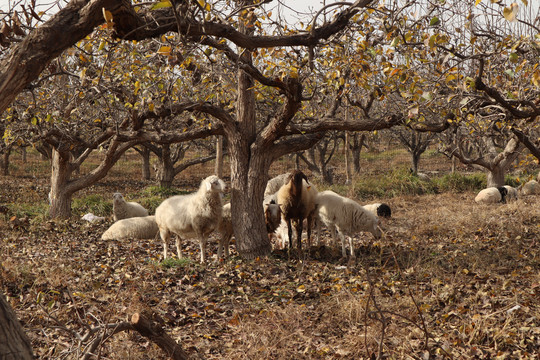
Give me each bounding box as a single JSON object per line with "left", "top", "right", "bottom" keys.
{"left": 101, "top": 215, "right": 159, "bottom": 240}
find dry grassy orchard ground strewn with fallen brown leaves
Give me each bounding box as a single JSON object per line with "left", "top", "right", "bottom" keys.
{"left": 0, "top": 149, "right": 540, "bottom": 359}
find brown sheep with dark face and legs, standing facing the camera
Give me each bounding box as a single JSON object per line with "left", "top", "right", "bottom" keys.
{"left": 277, "top": 170, "right": 317, "bottom": 250}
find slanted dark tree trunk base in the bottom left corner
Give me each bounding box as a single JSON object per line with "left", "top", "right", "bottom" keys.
{"left": 0, "top": 294, "right": 34, "bottom": 360}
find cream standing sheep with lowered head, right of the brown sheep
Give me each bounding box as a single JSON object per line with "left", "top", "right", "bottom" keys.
{"left": 317, "top": 190, "right": 382, "bottom": 257}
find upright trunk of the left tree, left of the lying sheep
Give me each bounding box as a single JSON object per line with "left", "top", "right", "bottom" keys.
{"left": 49, "top": 148, "right": 73, "bottom": 219}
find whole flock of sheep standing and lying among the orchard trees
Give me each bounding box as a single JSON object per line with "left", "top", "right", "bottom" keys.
{"left": 102, "top": 170, "right": 540, "bottom": 263}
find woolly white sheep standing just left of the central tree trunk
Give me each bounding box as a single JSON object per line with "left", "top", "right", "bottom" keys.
{"left": 156, "top": 175, "right": 225, "bottom": 263}
